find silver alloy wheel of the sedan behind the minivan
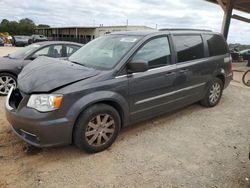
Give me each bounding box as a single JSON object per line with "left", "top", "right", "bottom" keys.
{"left": 0, "top": 76, "right": 16, "bottom": 95}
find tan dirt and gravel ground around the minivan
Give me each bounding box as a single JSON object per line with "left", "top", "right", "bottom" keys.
{"left": 0, "top": 49, "right": 250, "bottom": 188}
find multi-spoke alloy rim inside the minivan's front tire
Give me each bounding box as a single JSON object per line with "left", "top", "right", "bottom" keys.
{"left": 85, "top": 114, "right": 115, "bottom": 147}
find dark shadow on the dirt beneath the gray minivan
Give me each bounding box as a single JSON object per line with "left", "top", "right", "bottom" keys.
{"left": 20, "top": 103, "right": 207, "bottom": 160}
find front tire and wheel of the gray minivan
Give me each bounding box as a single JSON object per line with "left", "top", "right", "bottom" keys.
{"left": 73, "top": 104, "right": 121, "bottom": 153}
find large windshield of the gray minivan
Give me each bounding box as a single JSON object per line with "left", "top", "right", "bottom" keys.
{"left": 69, "top": 35, "right": 140, "bottom": 70}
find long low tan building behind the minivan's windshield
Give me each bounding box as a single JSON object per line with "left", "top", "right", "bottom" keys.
{"left": 34, "top": 25, "right": 153, "bottom": 44}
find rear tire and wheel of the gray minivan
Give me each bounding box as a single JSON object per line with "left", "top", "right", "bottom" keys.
{"left": 200, "top": 78, "right": 223, "bottom": 107}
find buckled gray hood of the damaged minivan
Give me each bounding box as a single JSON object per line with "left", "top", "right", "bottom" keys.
{"left": 17, "top": 57, "right": 100, "bottom": 94}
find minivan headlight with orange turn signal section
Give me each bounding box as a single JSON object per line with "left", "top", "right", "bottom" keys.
{"left": 27, "top": 94, "right": 63, "bottom": 112}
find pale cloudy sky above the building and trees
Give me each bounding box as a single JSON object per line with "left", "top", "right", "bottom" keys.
{"left": 0, "top": 0, "right": 250, "bottom": 44}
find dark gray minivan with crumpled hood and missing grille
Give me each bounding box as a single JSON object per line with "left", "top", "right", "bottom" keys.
{"left": 6, "top": 29, "right": 232, "bottom": 152}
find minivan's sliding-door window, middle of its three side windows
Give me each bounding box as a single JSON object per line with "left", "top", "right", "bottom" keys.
{"left": 174, "top": 35, "right": 204, "bottom": 63}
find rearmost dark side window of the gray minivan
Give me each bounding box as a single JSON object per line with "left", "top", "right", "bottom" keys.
{"left": 204, "top": 35, "right": 228, "bottom": 56}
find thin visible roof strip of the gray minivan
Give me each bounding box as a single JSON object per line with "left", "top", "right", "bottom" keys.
{"left": 111, "top": 29, "right": 219, "bottom": 36}
